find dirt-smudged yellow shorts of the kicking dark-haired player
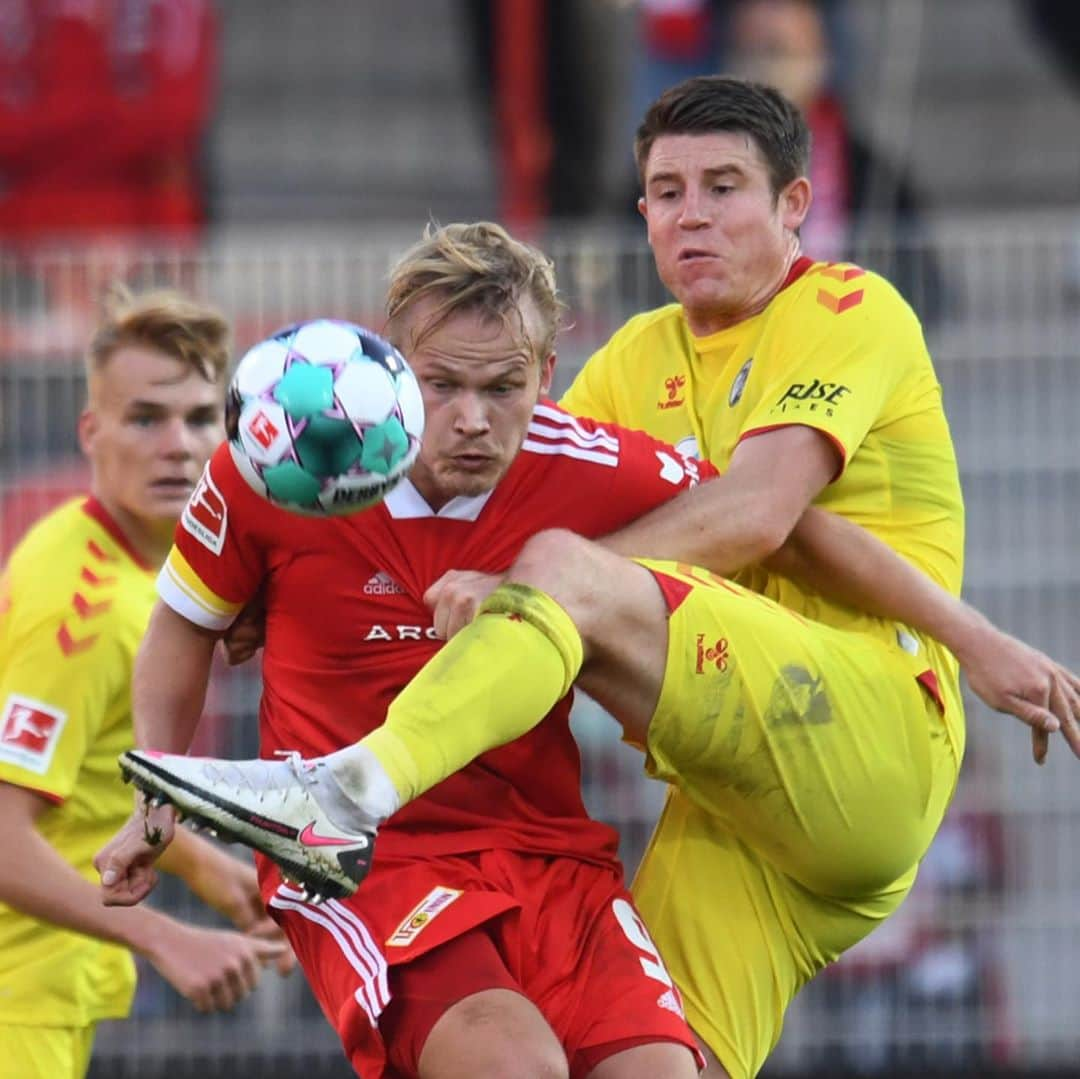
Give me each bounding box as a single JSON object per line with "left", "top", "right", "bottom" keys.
{"left": 633, "top": 562, "right": 959, "bottom": 1079}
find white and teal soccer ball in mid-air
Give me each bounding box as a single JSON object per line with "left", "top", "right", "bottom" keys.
{"left": 226, "top": 319, "right": 423, "bottom": 516}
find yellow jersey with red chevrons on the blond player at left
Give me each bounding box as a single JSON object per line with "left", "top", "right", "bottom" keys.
{"left": 0, "top": 498, "right": 156, "bottom": 1026}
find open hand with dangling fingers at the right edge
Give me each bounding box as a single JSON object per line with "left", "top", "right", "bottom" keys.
{"left": 958, "top": 622, "right": 1080, "bottom": 765}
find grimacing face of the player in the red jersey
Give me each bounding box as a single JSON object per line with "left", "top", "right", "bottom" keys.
{"left": 403, "top": 300, "right": 555, "bottom": 510}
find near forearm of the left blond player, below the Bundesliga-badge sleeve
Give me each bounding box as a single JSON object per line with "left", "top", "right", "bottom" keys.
{"left": 0, "top": 830, "right": 165, "bottom": 954}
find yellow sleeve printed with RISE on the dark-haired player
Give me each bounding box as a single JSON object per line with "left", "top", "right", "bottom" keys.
{"left": 740, "top": 265, "right": 929, "bottom": 471}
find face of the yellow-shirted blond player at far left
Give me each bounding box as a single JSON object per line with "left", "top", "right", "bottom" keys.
{"left": 79, "top": 346, "right": 225, "bottom": 535}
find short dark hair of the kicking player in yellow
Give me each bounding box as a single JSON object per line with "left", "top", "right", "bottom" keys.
{"left": 634, "top": 75, "right": 810, "bottom": 197}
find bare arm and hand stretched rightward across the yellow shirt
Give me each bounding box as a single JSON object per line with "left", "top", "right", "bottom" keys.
{"left": 766, "top": 507, "right": 1080, "bottom": 764}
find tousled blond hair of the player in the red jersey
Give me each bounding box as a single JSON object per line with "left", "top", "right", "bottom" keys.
{"left": 386, "top": 221, "right": 565, "bottom": 360}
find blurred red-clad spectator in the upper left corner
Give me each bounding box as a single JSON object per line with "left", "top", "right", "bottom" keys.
{"left": 0, "top": 0, "right": 216, "bottom": 245}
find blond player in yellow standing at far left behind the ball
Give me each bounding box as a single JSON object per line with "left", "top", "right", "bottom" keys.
{"left": 0, "top": 289, "right": 284, "bottom": 1079}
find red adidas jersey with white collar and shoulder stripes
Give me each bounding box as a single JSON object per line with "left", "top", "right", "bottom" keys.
{"left": 159, "top": 402, "right": 715, "bottom": 861}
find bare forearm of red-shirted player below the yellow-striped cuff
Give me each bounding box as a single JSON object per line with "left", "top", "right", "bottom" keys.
{"left": 132, "top": 602, "right": 217, "bottom": 753}
